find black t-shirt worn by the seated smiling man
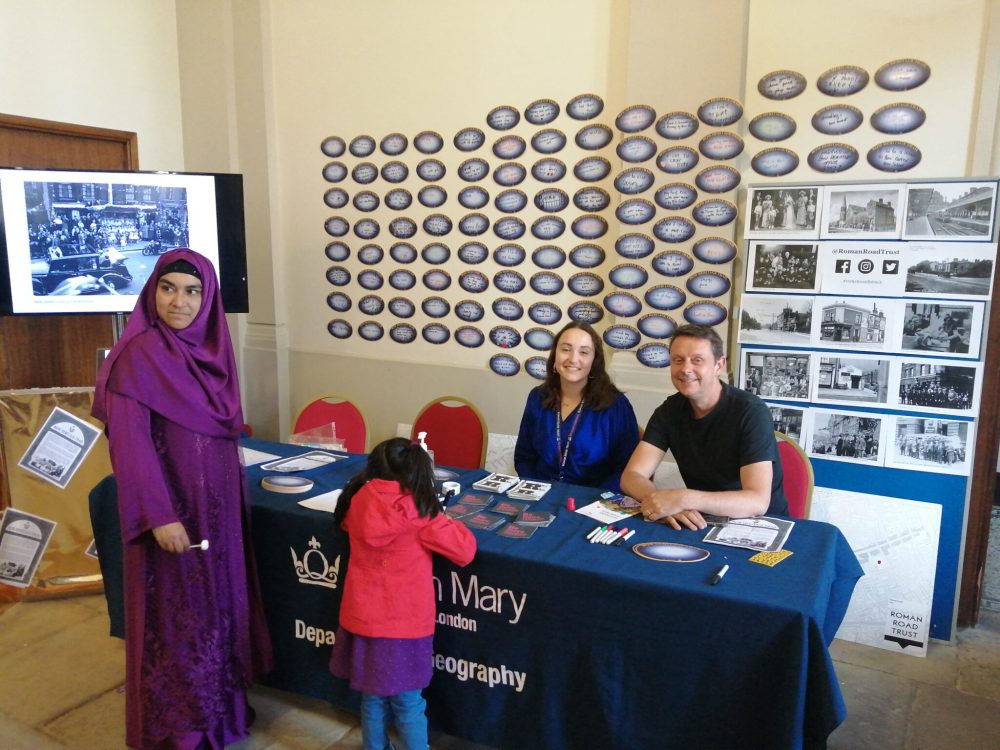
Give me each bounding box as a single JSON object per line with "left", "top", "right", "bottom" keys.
{"left": 642, "top": 383, "right": 788, "bottom": 515}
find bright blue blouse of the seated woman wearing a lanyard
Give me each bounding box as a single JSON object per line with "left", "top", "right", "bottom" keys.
{"left": 514, "top": 387, "right": 639, "bottom": 492}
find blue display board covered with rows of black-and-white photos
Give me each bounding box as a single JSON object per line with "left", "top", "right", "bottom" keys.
{"left": 733, "top": 180, "right": 997, "bottom": 638}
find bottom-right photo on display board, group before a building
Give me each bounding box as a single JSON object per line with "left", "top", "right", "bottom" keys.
{"left": 886, "top": 414, "right": 975, "bottom": 475}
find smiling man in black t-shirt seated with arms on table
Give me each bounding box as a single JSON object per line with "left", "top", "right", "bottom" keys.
{"left": 621, "top": 325, "right": 788, "bottom": 529}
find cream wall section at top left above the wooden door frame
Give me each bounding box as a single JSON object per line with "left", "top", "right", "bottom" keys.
{"left": 0, "top": 0, "right": 184, "bottom": 170}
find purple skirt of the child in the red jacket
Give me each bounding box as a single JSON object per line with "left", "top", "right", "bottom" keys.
{"left": 330, "top": 628, "right": 434, "bottom": 695}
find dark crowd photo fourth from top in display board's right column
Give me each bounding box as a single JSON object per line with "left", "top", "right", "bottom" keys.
{"left": 889, "top": 356, "right": 982, "bottom": 417}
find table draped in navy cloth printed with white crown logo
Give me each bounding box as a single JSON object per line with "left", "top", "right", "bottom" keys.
{"left": 245, "top": 440, "right": 862, "bottom": 750}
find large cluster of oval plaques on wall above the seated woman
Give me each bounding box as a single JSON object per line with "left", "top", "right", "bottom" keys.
{"left": 321, "top": 94, "right": 744, "bottom": 378}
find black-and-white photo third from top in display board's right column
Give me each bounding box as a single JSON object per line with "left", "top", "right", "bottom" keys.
{"left": 897, "top": 300, "right": 983, "bottom": 359}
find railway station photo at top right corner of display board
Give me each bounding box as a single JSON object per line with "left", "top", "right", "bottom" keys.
{"left": 903, "top": 180, "right": 997, "bottom": 242}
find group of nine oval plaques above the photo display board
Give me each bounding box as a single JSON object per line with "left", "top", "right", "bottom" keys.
{"left": 748, "top": 59, "right": 931, "bottom": 177}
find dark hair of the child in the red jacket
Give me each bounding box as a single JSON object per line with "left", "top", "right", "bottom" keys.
{"left": 333, "top": 438, "right": 441, "bottom": 526}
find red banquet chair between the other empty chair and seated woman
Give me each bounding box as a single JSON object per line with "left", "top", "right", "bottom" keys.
{"left": 410, "top": 396, "right": 488, "bottom": 469}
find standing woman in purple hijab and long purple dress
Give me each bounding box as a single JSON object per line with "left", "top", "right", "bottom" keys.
{"left": 93, "top": 248, "right": 271, "bottom": 750}
